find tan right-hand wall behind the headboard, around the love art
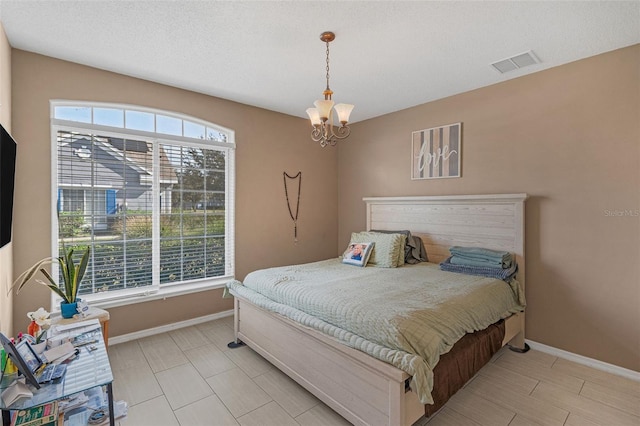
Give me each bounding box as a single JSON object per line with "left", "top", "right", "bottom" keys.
{"left": 338, "top": 45, "right": 640, "bottom": 370}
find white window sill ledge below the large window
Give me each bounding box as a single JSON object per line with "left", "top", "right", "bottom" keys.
{"left": 53, "top": 277, "right": 233, "bottom": 311}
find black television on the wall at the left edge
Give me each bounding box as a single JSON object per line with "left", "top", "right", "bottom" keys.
{"left": 0, "top": 124, "right": 17, "bottom": 248}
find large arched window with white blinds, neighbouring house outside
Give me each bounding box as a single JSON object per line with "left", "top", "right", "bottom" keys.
{"left": 52, "top": 101, "right": 235, "bottom": 300}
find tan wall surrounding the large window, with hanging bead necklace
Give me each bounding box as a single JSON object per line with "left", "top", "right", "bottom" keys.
{"left": 12, "top": 49, "right": 338, "bottom": 336}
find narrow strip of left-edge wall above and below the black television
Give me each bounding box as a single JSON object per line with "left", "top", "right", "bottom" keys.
{"left": 0, "top": 23, "right": 13, "bottom": 335}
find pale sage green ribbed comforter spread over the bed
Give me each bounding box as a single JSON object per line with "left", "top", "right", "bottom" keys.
{"left": 227, "top": 259, "right": 525, "bottom": 404}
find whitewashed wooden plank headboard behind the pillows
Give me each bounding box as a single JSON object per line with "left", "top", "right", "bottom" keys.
{"left": 363, "top": 194, "right": 527, "bottom": 285}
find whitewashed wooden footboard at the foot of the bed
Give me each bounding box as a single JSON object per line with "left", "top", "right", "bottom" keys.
{"left": 235, "top": 297, "right": 424, "bottom": 426}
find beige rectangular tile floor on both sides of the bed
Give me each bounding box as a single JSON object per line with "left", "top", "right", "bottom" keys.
{"left": 109, "top": 317, "right": 640, "bottom": 426}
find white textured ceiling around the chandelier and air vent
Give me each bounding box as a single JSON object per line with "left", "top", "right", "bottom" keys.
{"left": 0, "top": 0, "right": 640, "bottom": 121}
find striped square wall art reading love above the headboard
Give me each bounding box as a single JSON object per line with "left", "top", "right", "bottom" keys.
{"left": 411, "top": 123, "right": 462, "bottom": 179}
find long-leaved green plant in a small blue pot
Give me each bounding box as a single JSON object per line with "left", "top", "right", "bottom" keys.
{"left": 14, "top": 243, "right": 91, "bottom": 318}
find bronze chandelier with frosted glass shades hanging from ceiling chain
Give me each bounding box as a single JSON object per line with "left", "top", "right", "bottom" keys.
{"left": 307, "top": 31, "right": 353, "bottom": 147}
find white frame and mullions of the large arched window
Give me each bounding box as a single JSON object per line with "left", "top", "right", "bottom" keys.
{"left": 50, "top": 99, "right": 236, "bottom": 310}
